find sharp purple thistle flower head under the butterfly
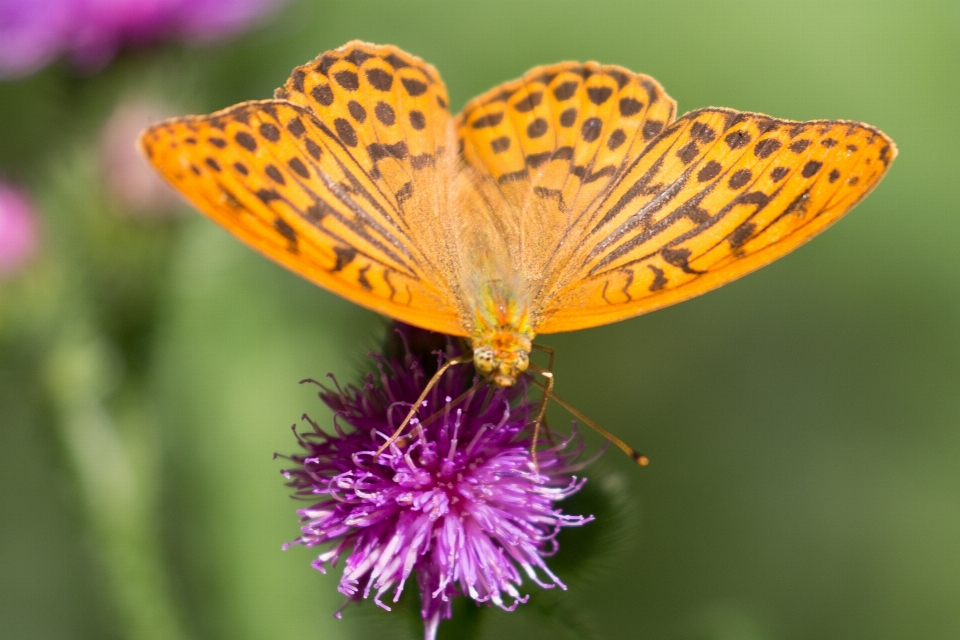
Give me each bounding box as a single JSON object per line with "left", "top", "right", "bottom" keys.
{"left": 284, "top": 325, "right": 592, "bottom": 640}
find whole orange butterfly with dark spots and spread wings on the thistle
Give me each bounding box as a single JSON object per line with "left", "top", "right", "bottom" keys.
{"left": 140, "top": 41, "right": 897, "bottom": 459}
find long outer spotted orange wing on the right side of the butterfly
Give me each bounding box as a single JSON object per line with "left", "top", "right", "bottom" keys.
{"left": 538, "top": 109, "right": 896, "bottom": 333}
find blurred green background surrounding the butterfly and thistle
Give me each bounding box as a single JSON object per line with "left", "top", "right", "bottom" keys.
{"left": 0, "top": 0, "right": 960, "bottom": 640}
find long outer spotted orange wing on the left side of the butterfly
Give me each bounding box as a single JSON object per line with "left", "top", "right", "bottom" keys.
{"left": 141, "top": 100, "right": 463, "bottom": 334}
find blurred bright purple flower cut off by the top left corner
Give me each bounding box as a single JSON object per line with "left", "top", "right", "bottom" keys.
{"left": 0, "top": 0, "right": 282, "bottom": 77}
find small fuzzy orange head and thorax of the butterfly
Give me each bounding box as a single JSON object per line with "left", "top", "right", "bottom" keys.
{"left": 471, "top": 282, "right": 534, "bottom": 387}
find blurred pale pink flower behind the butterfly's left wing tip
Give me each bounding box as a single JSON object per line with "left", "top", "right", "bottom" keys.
{"left": 100, "top": 96, "right": 183, "bottom": 216}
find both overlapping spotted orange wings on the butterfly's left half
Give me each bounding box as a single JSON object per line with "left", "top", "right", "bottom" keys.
{"left": 141, "top": 42, "right": 466, "bottom": 335}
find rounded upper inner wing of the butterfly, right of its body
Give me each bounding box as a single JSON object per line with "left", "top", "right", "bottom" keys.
{"left": 457, "top": 62, "right": 676, "bottom": 298}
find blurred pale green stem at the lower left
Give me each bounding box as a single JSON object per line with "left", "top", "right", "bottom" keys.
{"left": 47, "top": 325, "right": 186, "bottom": 640}
